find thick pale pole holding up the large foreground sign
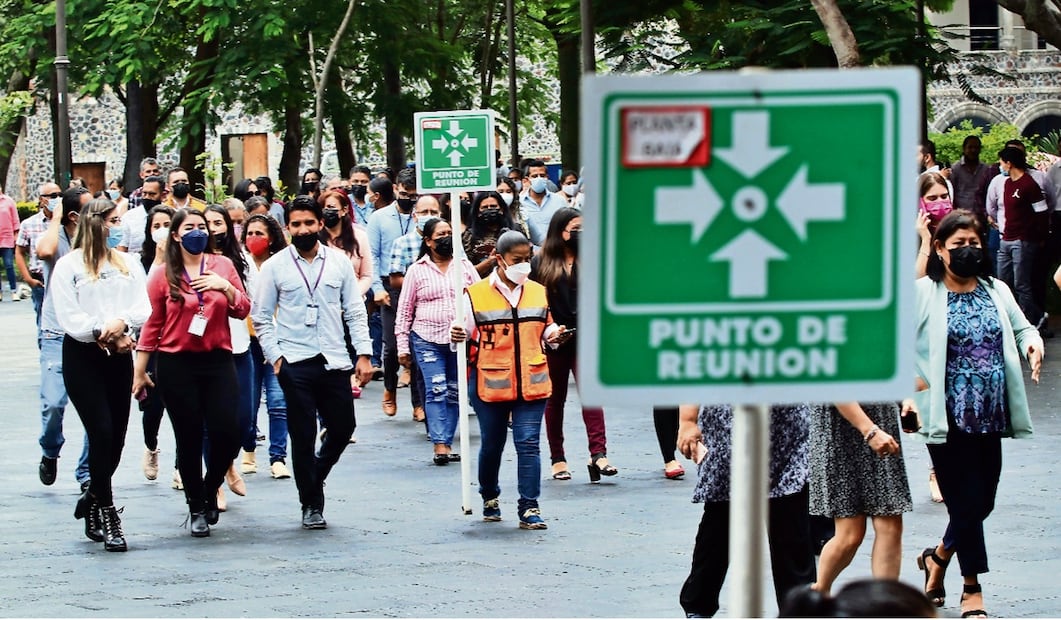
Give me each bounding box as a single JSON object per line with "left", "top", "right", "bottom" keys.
{"left": 729, "top": 404, "right": 770, "bottom": 618}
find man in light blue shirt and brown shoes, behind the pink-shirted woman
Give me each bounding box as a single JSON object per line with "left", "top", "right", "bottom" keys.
{"left": 368, "top": 168, "right": 420, "bottom": 415}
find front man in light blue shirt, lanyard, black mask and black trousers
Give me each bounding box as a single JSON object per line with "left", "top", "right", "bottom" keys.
{"left": 250, "top": 195, "right": 372, "bottom": 530}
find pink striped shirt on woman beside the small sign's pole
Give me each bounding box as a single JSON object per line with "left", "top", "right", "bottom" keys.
{"left": 395, "top": 255, "right": 480, "bottom": 355}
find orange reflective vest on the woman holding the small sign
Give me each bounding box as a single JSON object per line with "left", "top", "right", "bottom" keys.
{"left": 468, "top": 278, "right": 553, "bottom": 402}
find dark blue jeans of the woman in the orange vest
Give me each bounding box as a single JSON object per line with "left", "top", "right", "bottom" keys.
{"left": 468, "top": 369, "right": 545, "bottom": 514}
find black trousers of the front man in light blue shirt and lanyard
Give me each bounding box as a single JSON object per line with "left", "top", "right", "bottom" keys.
{"left": 277, "top": 356, "right": 356, "bottom": 509}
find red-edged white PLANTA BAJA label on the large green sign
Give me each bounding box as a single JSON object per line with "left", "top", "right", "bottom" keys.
{"left": 622, "top": 106, "right": 711, "bottom": 168}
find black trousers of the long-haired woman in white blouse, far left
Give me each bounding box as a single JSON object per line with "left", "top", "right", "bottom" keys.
{"left": 63, "top": 335, "right": 133, "bottom": 506}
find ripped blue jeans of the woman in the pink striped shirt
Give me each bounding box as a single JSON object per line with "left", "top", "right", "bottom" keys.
{"left": 408, "top": 332, "right": 460, "bottom": 446}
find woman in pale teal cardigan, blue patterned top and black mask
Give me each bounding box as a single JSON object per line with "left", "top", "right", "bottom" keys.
{"left": 915, "top": 210, "right": 1043, "bottom": 618}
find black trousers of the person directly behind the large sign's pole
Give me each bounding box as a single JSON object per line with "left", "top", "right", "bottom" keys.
{"left": 679, "top": 485, "right": 815, "bottom": 617}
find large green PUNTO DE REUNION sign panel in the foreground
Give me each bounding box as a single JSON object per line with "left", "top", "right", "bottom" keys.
{"left": 579, "top": 69, "right": 920, "bottom": 404}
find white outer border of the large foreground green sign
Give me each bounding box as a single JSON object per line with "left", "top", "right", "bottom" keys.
{"left": 578, "top": 67, "right": 923, "bottom": 407}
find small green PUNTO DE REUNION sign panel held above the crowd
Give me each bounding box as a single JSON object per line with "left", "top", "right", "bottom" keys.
{"left": 413, "top": 109, "right": 497, "bottom": 193}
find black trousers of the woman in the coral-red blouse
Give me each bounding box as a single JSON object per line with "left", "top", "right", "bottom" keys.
{"left": 157, "top": 349, "right": 240, "bottom": 512}
